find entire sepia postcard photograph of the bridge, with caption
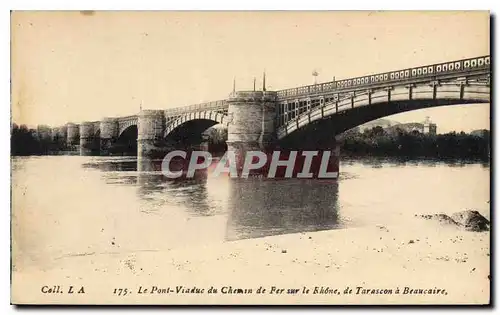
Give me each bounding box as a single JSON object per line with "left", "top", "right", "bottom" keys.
{"left": 10, "top": 10, "right": 493, "bottom": 306}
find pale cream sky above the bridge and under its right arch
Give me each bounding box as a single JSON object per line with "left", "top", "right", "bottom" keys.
{"left": 11, "top": 11, "right": 490, "bottom": 133}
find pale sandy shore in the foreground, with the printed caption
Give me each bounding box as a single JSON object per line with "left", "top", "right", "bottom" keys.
{"left": 13, "top": 218, "right": 490, "bottom": 304}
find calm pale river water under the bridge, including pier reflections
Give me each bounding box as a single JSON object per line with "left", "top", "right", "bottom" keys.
{"left": 12, "top": 156, "right": 490, "bottom": 268}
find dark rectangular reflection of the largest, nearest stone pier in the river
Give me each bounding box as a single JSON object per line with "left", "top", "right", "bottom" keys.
{"left": 226, "top": 179, "right": 341, "bottom": 240}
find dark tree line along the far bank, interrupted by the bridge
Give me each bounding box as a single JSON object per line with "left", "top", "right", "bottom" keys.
{"left": 11, "top": 124, "right": 490, "bottom": 159}
